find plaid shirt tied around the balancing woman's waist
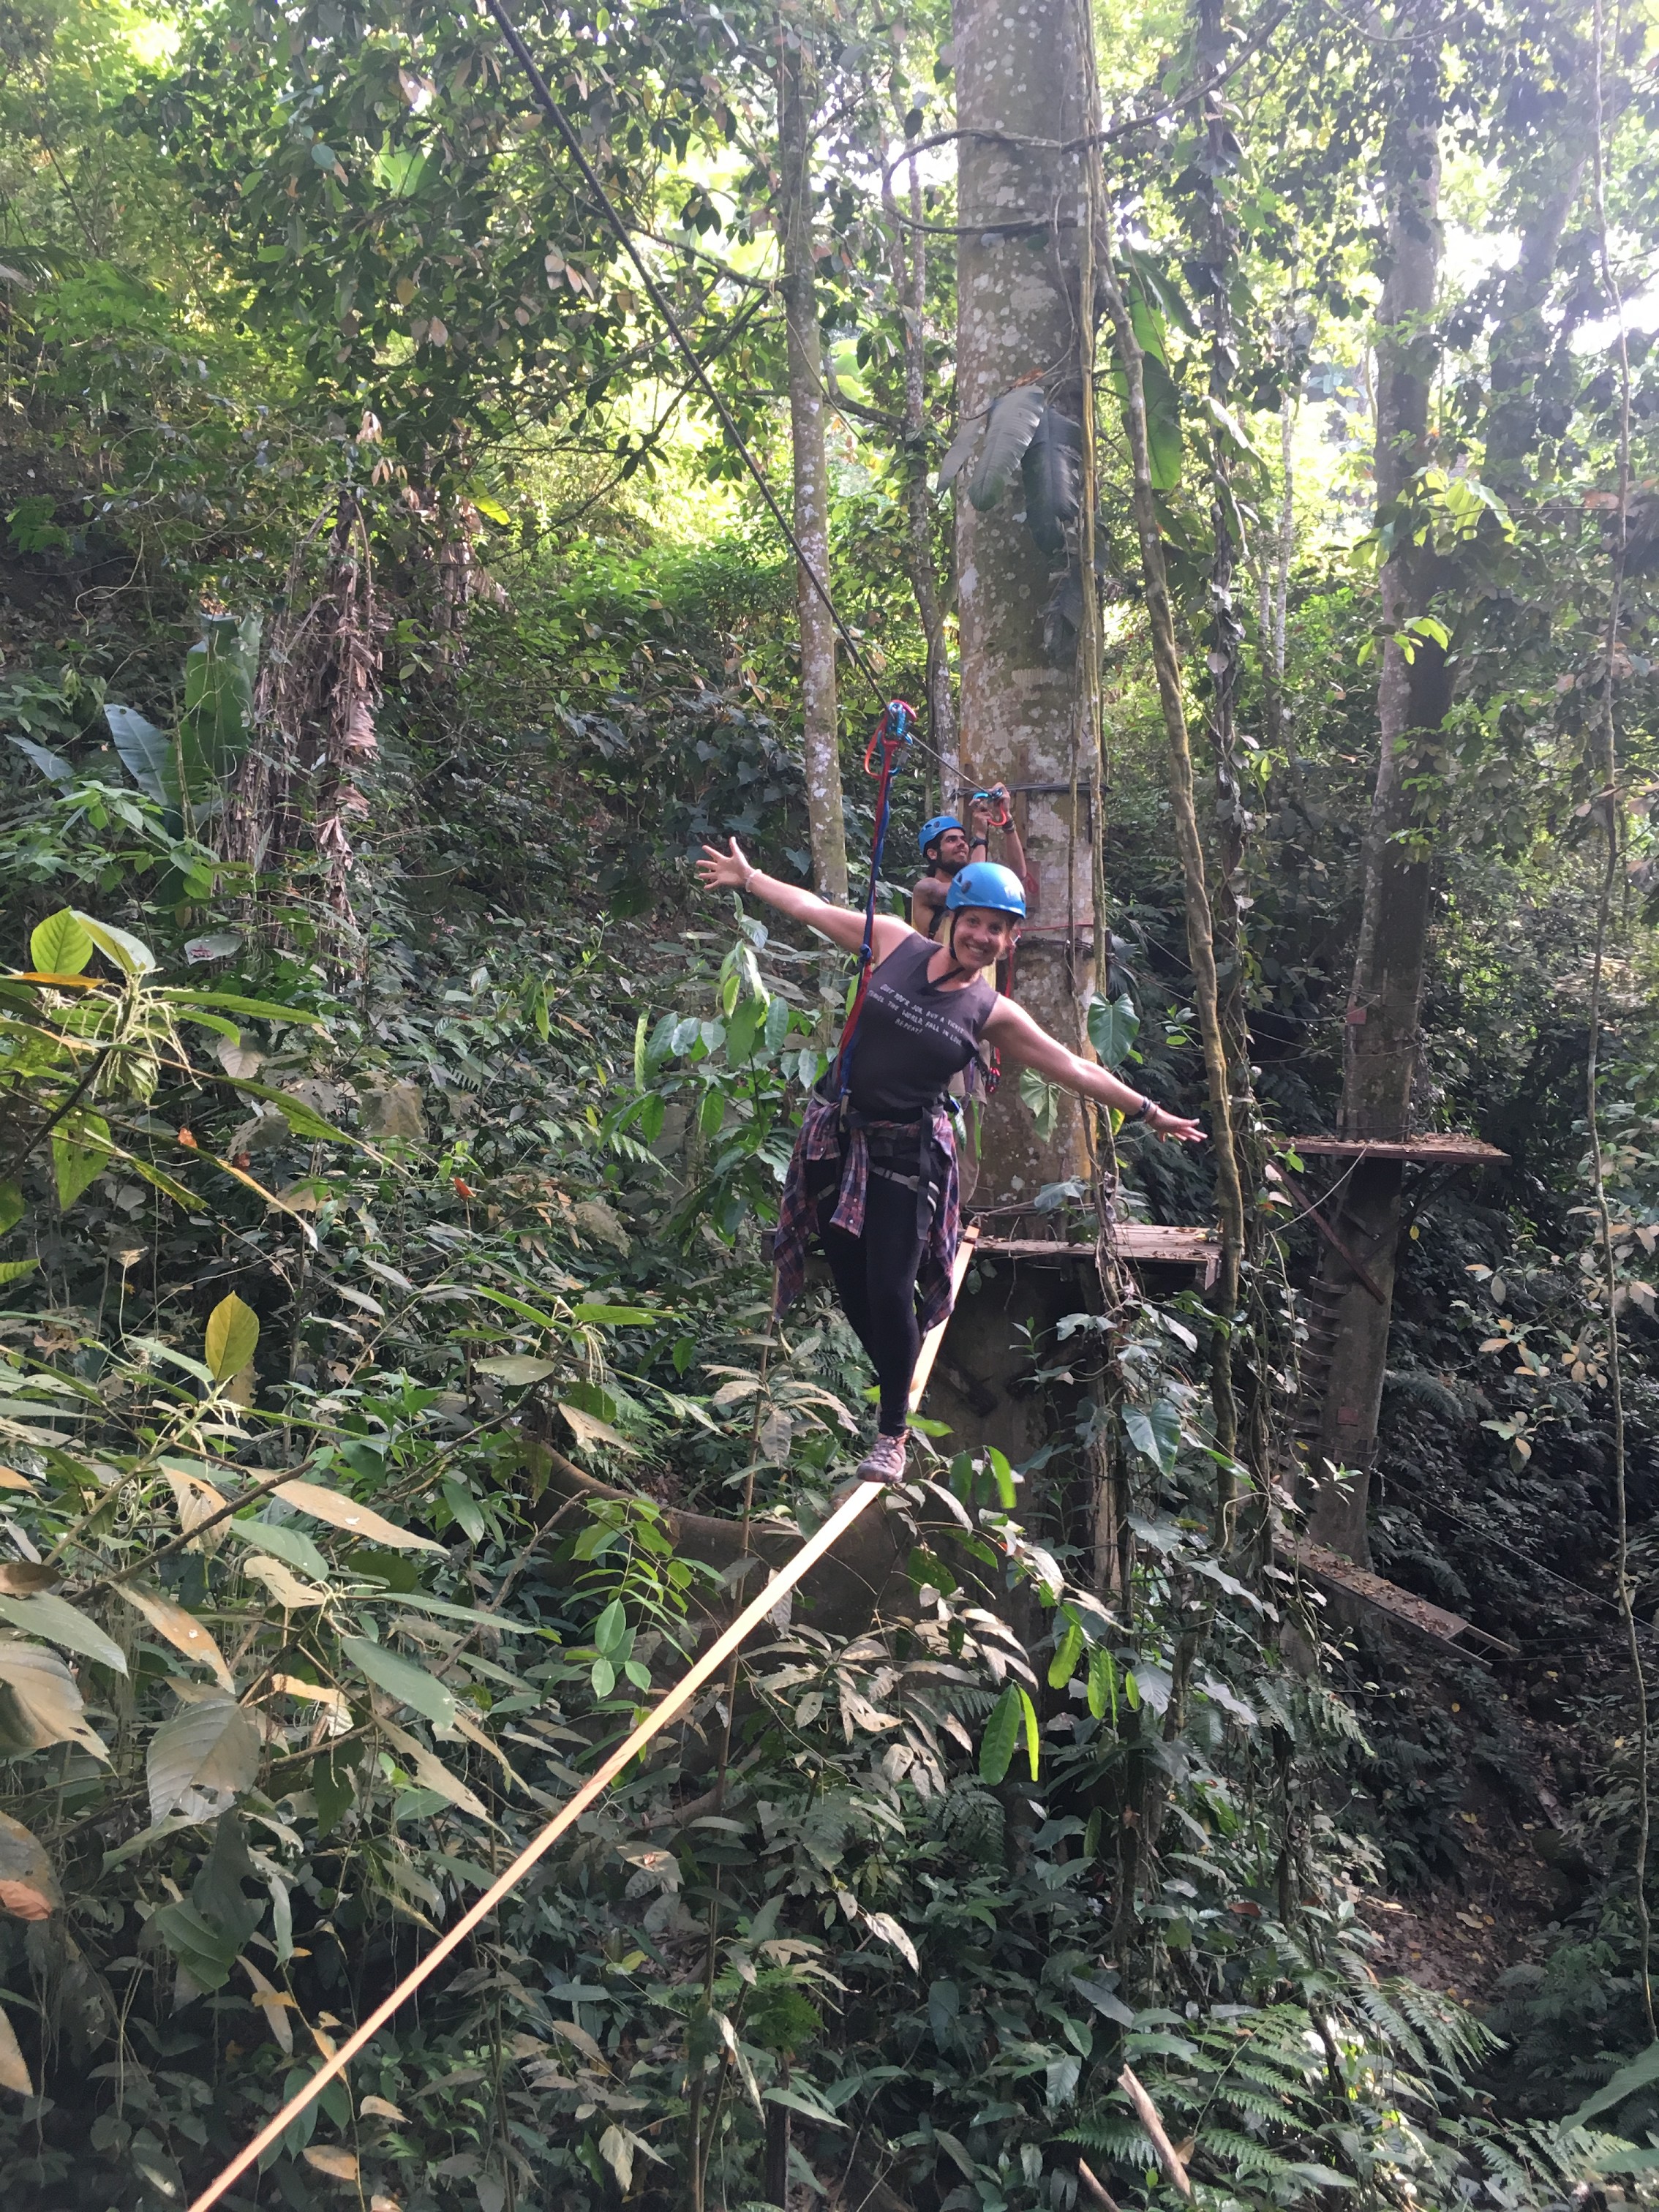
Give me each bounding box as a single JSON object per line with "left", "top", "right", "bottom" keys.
{"left": 772, "top": 1097, "right": 962, "bottom": 1333}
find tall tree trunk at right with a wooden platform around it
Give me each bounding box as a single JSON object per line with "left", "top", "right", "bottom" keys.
{"left": 1307, "top": 86, "right": 1449, "bottom": 1562}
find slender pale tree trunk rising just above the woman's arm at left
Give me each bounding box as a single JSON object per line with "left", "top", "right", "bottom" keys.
{"left": 778, "top": 33, "right": 847, "bottom": 903}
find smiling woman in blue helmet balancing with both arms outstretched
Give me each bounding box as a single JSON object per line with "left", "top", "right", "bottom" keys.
{"left": 697, "top": 838, "right": 1203, "bottom": 1482}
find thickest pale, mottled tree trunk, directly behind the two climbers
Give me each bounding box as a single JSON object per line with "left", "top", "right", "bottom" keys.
{"left": 953, "top": 0, "right": 1095, "bottom": 1205}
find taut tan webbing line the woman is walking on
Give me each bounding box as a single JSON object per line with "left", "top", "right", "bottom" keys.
{"left": 188, "top": 1225, "right": 980, "bottom": 2212}
